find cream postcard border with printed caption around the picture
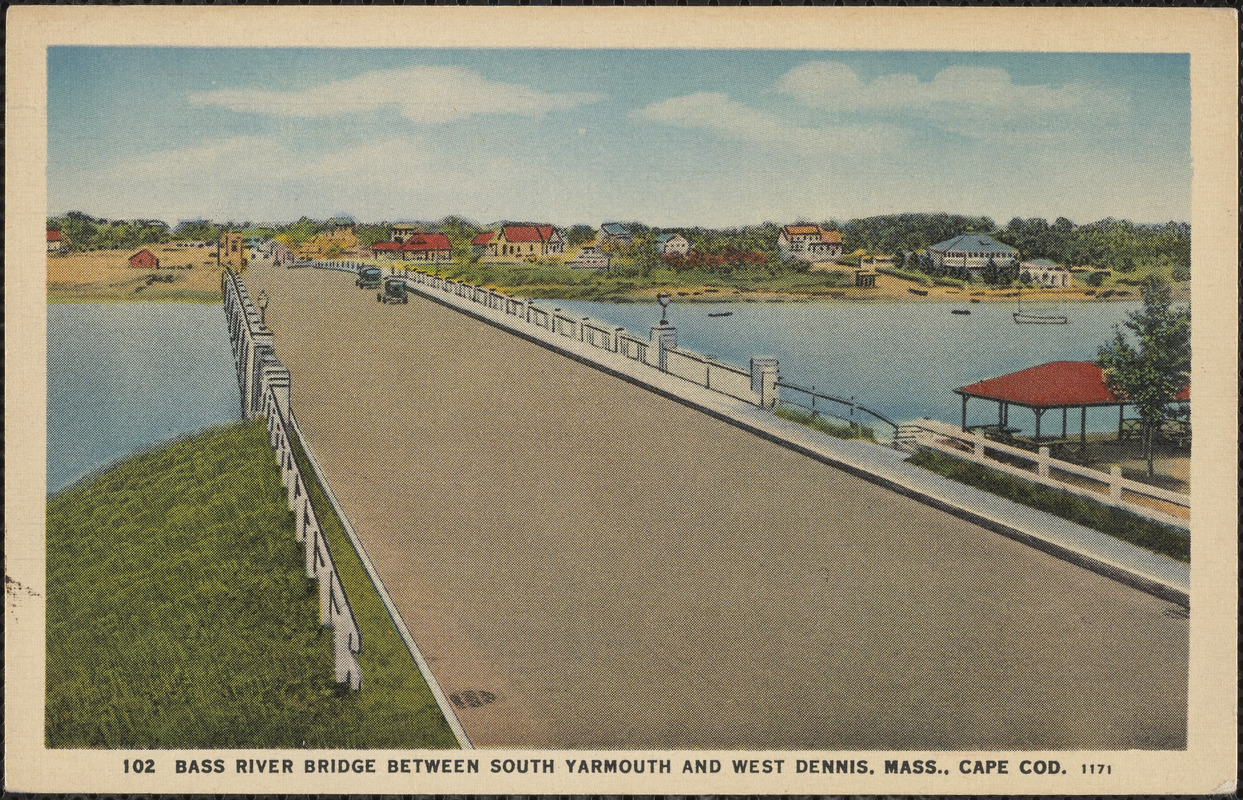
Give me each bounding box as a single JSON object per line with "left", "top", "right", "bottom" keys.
{"left": 5, "top": 6, "right": 1238, "bottom": 794}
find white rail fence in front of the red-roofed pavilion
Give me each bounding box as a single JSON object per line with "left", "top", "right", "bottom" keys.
{"left": 902, "top": 420, "right": 1191, "bottom": 530}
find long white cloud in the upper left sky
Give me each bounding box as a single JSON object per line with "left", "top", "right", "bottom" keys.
{"left": 190, "top": 67, "right": 604, "bottom": 124}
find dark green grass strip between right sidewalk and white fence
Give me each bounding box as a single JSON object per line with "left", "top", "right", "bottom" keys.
{"left": 906, "top": 450, "right": 1191, "bottom": 564}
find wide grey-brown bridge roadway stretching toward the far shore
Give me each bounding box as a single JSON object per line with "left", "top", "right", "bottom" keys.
{"left": 245, "top": 265, "right": 1188, "bottom": 749}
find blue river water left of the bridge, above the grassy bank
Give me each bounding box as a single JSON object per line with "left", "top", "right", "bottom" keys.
{"left": 47, "top": 303, "right": 241, "bottom": 492}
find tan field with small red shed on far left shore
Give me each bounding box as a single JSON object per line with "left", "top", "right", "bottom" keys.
{"left": 47, "top": 245, "right": 220, "bottom": 303}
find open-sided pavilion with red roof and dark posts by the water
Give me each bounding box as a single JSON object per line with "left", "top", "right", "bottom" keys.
{"left": 955, "top": 361, "right": 1191, "bottom": 447}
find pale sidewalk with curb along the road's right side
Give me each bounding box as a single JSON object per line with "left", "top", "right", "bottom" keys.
{"left": 408, "top": 274, "right": 1191, "bottom": 607}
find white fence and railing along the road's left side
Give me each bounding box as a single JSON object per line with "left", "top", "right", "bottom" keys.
{"left": 221, "top": 271, "right": 363, "bottom": 689}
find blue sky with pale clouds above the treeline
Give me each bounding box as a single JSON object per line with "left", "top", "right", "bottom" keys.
{"left": 47, "top": 47, "right": 1191, "bottom": 226}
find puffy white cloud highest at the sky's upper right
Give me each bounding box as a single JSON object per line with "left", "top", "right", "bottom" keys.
{"left": 777, "top": 61, "right": 1130, "bottom": 132}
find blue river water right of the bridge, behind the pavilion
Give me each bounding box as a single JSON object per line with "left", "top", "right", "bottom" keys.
{"left": 554, "top": 295, "right": 1140, "bottom": 430}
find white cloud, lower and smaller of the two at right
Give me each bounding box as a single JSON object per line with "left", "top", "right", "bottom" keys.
{"left": 630, "top": 92, "right": 902, "bottom": 155}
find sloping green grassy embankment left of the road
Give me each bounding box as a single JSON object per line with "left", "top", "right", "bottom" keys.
{"left": 46, "top": 422, "right": 456, "bottom": 748}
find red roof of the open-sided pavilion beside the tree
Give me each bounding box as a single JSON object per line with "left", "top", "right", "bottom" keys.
{"left": 955, "top": 361, "right": 1191, "bottom": 409}
